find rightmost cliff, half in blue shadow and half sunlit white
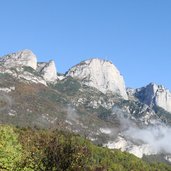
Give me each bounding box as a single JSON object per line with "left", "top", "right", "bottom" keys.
{"left": 136, "top": 83, "right": 171, "bottom": 112}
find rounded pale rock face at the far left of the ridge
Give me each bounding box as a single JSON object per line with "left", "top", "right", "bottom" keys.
{"left": 0, "top": 50, "right": 37, "bottom": 69}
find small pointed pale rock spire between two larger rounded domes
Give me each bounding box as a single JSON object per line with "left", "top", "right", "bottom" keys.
{"left": 38, "top": 60, "right": 57, "bottom": 82}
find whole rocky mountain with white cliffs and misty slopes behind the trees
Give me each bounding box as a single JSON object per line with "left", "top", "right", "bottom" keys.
{"left": 0, "top": 50, "right": 171, "bottom": 163}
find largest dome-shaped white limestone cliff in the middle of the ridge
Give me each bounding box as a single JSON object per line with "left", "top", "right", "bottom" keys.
{"left": 66, "top": 58, "right": 128, "bottom": 99}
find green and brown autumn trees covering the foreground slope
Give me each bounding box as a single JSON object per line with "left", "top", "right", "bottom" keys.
{"left": 0, "top": 125, "right": 171, "bottom": 171}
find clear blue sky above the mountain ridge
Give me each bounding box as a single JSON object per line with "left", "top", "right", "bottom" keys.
{"left": 0, "top": 0, "right": 171, "bottom": 90}
